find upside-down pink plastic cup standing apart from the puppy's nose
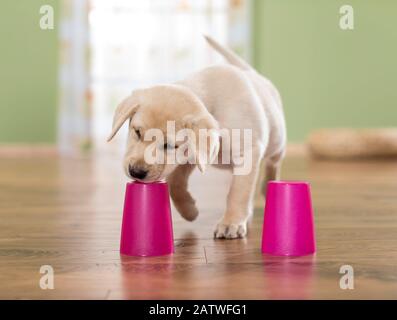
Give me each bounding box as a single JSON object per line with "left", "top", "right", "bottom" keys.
{"left": 262, "top": 181, "right": 316, "bottom": 256}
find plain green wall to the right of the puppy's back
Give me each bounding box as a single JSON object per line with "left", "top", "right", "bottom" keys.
{"left": 254, "top": 0, "right": 397, "bottom": 141}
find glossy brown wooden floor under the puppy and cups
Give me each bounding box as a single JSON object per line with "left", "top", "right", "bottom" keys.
{"left": 0, "top": 153, "right": 397, "bottom": 299}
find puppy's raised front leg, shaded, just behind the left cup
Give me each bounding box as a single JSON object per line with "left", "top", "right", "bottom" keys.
{"left": 167, "top": 164, "right": 198, "bottom": 221}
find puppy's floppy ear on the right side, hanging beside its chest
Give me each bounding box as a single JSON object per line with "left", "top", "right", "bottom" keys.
{"left": 185, "top": 112, "right": 220, "bottom": 172}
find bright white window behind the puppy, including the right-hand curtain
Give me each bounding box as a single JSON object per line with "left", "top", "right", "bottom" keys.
{"left": 57, "top": 0, "right": 250, "bottom": 152}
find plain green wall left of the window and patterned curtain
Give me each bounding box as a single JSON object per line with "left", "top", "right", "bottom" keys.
{"left": 0, "top": 0, "right": 59, "bottom": 143}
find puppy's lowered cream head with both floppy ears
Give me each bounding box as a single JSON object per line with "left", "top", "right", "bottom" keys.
{"left": 108, "top": 85, "right": 219, "bottom": 182}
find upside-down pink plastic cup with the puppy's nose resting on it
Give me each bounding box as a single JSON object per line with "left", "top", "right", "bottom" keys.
{"left": 120, "top": 182, "right": 174, "bottom": 256}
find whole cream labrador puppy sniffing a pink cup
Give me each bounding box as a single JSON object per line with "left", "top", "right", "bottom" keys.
{"left": 109, "top": 37, "right": 286, "bottom": 239}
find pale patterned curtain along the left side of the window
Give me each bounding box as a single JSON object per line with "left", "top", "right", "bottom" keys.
{"left": 58, "top": 0, "right": 92, "bottom": 153}
